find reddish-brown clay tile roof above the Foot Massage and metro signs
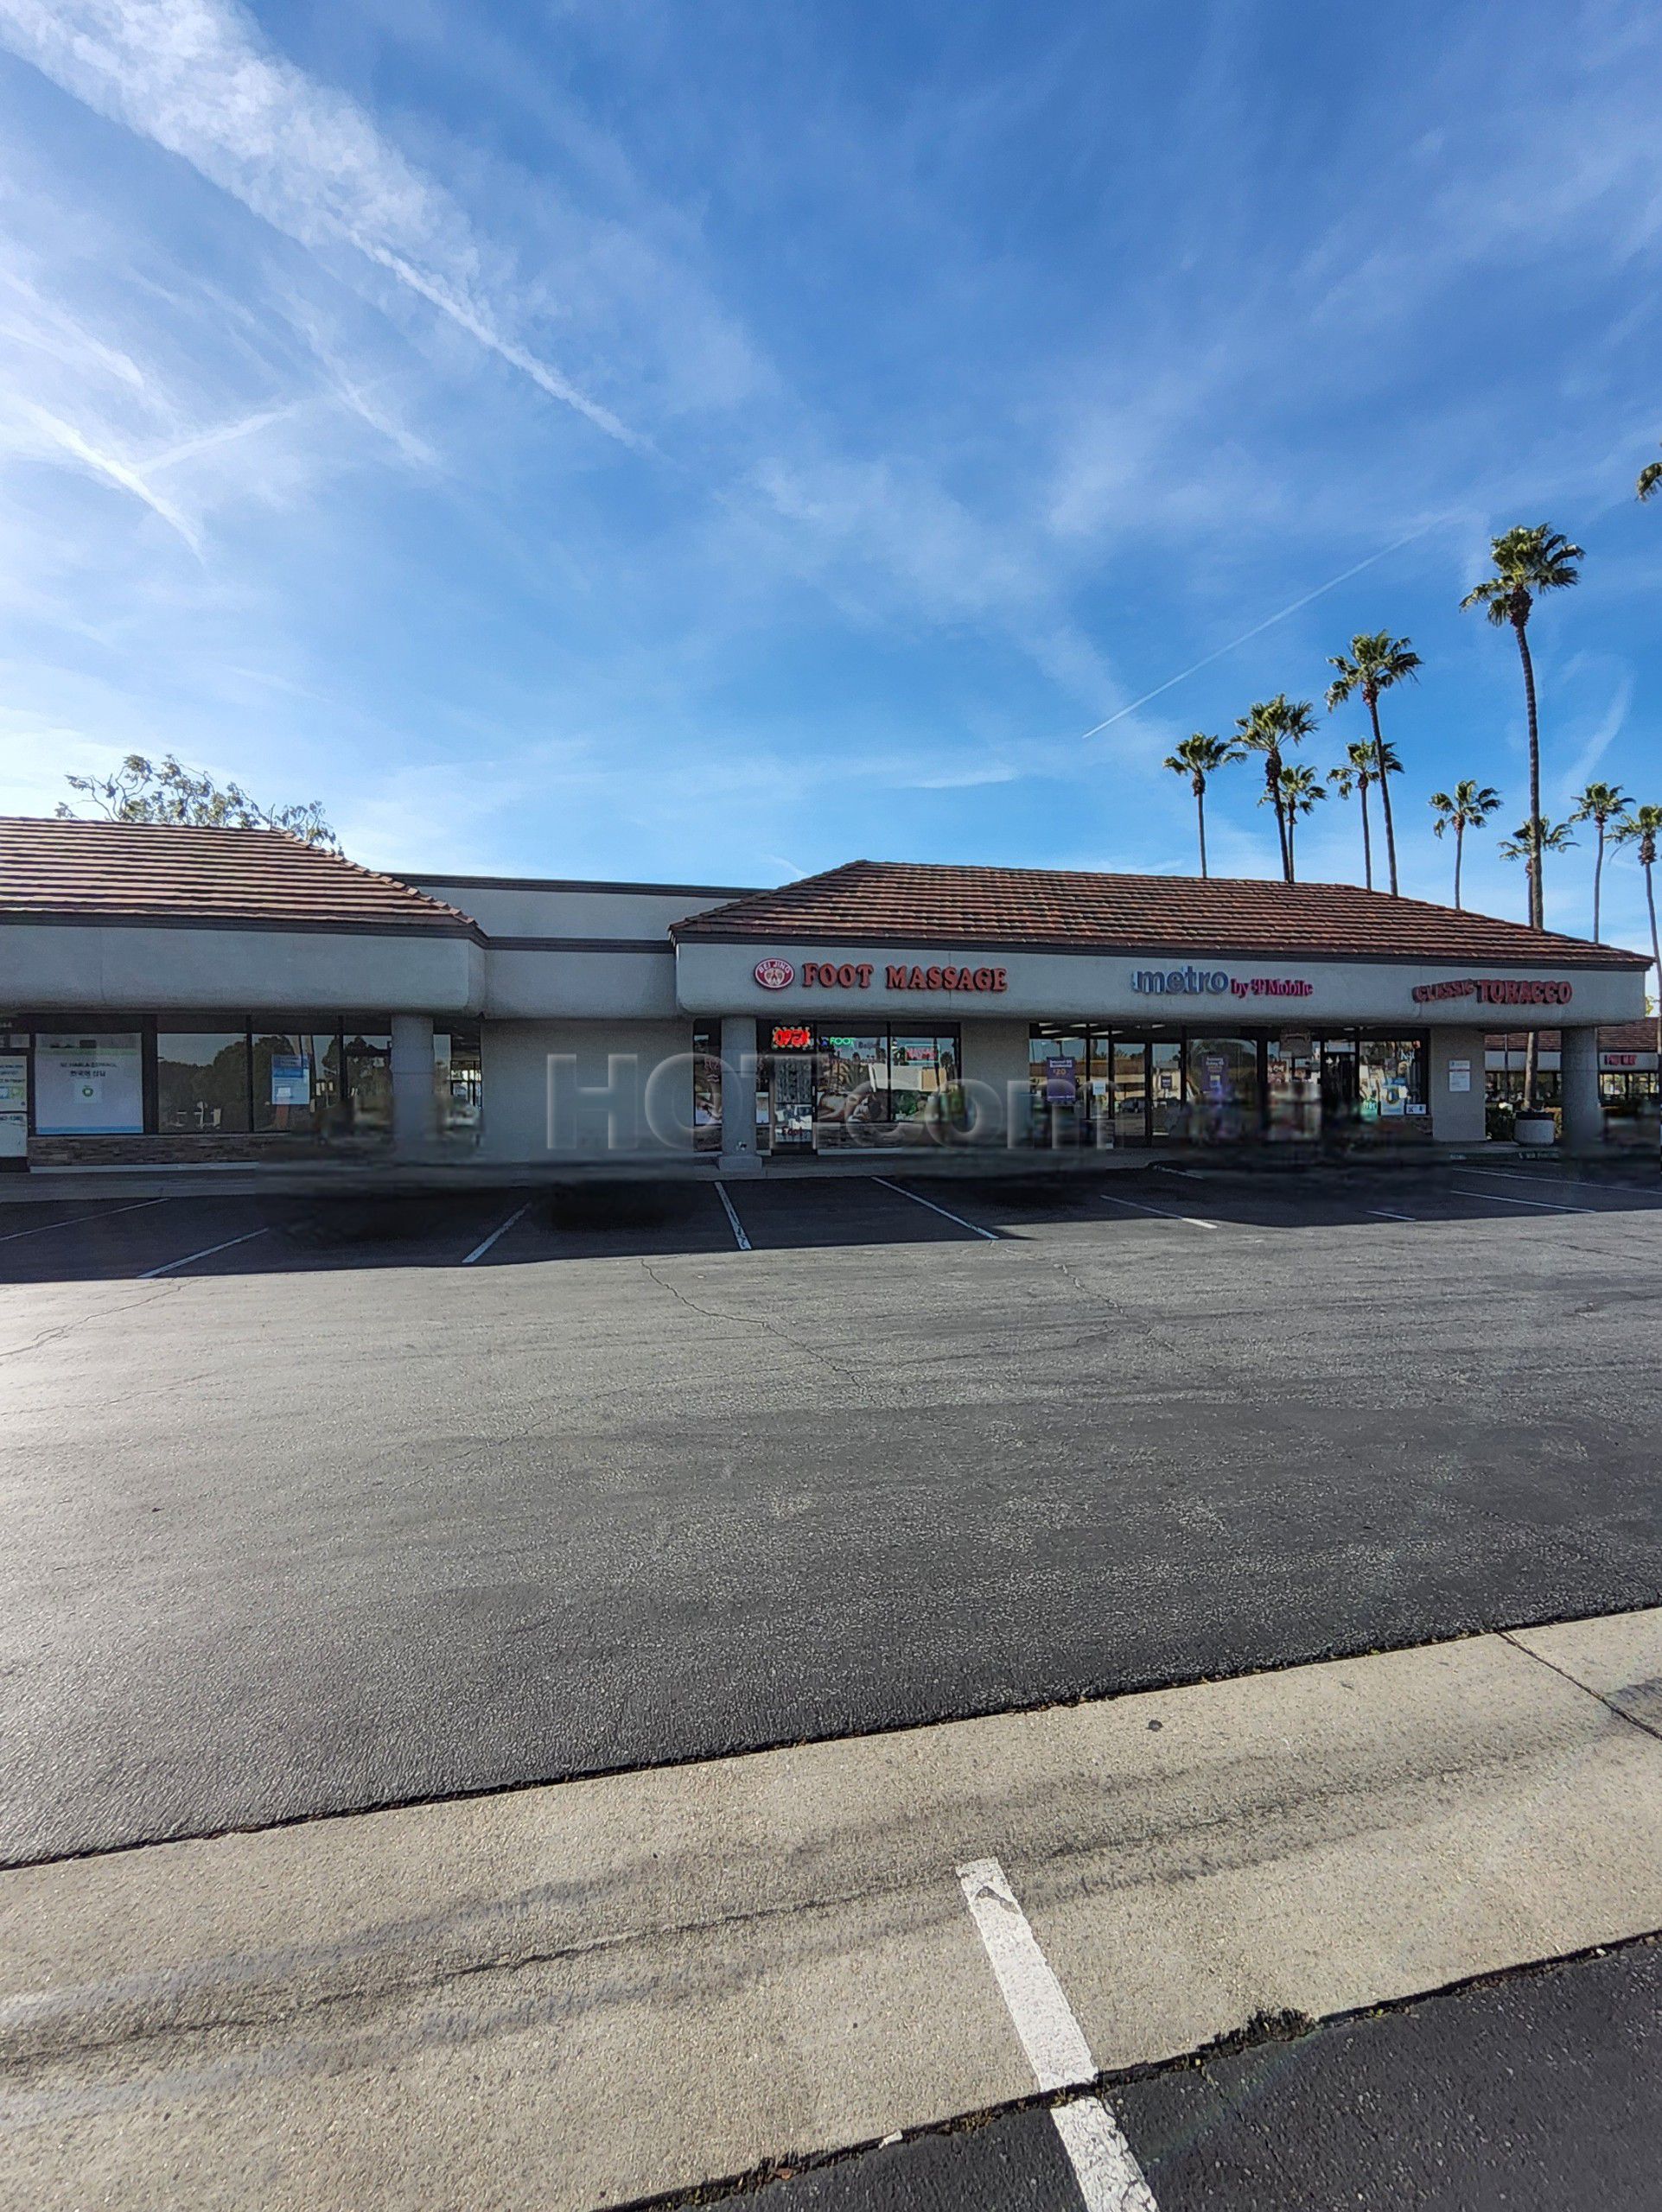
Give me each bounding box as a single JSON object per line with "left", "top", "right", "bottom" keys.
{"left": 671, "top": 861, "right": 1649, "bottom": 967}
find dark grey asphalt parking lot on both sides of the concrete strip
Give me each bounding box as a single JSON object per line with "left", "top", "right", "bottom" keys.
{"left": 0, "top": 1164, "right": 1662, "bottom": 2212}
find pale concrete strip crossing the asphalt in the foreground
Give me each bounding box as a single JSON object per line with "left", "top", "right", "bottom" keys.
{"left": 0, "top": 1611, "right": 1662, "bottom": 2212}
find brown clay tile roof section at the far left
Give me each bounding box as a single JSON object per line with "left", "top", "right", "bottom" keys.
{"left": 0, "top": 814, "right": 478, "bottom": 936}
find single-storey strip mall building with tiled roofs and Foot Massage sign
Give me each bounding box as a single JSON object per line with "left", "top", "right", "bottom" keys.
{"left": 0, "top": 818, "right": 1651, "bottom": 1173}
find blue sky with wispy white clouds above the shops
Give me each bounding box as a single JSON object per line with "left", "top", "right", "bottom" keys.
{"left": 0, "top": 0, "right": 1662, "bottom": 943}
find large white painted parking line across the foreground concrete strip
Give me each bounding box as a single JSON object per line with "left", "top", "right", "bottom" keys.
{"left": 958, "top": 1858, "right": 1157, "bottom": 2212}
